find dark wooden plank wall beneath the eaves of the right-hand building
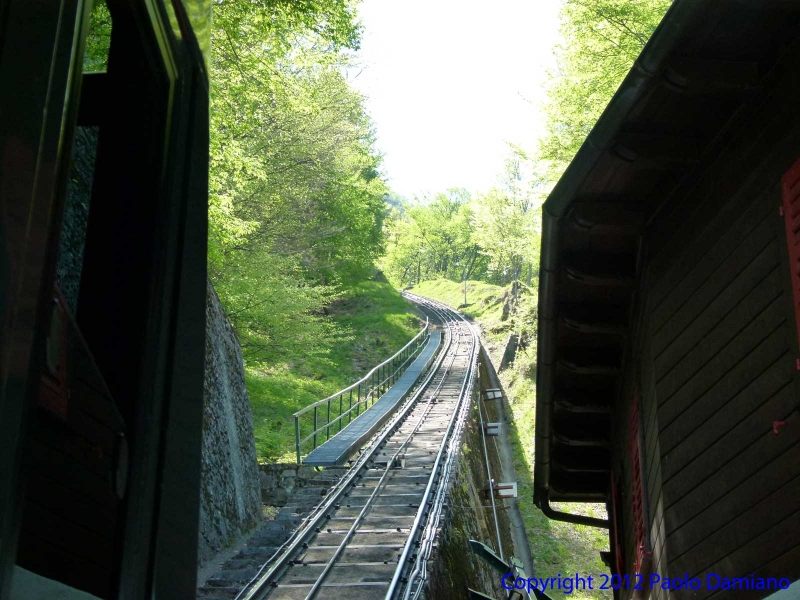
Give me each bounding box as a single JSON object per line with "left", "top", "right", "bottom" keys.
{"left": 637, "top": 41, "right": 800, "bottom": 598}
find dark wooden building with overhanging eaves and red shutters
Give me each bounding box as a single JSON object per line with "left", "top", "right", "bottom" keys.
{"left": 534, "top": 0, "right": 800, "bottom": 599}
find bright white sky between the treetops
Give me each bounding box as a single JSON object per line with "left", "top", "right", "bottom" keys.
{"left": 350, "top": 0, "right": 561, "bottom": 198}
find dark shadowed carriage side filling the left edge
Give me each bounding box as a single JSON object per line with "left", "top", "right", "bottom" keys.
{"left": 0, "top": 0, "right": 210, "bottom": 599}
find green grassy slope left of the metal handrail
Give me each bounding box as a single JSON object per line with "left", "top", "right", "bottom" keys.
{"left": 245, "top": 281, "right": 422, "bottom": 462}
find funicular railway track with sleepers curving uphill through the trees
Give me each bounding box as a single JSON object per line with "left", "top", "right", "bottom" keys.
{"left": 236, "top": 294, "right": 479, "bottom": 600}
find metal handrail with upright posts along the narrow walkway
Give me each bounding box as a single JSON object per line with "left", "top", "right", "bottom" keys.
{"left": 293, "top": 317, "right": 430, "bottom": 464}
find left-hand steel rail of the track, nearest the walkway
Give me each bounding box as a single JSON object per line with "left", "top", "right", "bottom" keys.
{"left": 234, "top": 310, "right": 455, "bottom": 600}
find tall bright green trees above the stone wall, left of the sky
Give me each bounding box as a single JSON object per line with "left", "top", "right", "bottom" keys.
{"left": 209, "top": 0, "right": 387, "bottom": 368}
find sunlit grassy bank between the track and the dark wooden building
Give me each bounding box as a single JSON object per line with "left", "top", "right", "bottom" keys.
{"left": 411, "top": 279, "right": 611, "bottom": 599}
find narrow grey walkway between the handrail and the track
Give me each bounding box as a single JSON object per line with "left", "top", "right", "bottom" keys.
{"left": 303, "top": 330, "right": 442, "bottom": 467}
